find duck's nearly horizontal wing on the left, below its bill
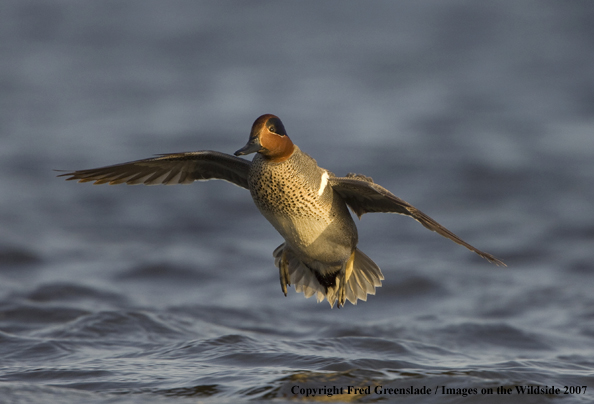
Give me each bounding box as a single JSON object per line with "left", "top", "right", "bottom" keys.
{"left": 58, "top": 150, "right": 251, "bottom": 189}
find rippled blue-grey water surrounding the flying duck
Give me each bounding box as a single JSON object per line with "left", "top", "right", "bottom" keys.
{"left": 0, "top": 0, "right": 594, "bottom": 404}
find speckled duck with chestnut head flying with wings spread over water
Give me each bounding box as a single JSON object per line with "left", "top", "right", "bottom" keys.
{"left": 59, "top": 114, "right": 505, "bottom": 307}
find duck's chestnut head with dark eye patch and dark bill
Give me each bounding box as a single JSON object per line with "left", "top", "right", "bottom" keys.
{"left": 235, "top": 114, "right": 295, "bottom": 162}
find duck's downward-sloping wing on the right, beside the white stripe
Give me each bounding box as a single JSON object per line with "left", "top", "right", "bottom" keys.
{"left": 328, "top": 174, "right": 506, "bottom": 266}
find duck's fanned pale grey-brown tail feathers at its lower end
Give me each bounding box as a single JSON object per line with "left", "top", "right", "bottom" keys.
{"left": 273, "top": 244, "right": 384, "bottom": 307}
